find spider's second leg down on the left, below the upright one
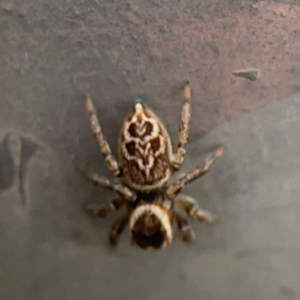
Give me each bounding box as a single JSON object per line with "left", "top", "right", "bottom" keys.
{"left": 77, "top": 168, "right": 136, "bottom": 201}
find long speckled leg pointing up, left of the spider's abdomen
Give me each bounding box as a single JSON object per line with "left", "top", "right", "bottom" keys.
{"left": 86, "top": 97, "right": 121, "bottom": 176}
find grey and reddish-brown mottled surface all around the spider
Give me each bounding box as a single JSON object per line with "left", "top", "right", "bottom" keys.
{"left": 0, "top": 0, "right": 300, "bottom": 300}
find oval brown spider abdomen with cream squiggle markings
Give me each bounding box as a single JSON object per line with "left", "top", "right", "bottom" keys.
{"left": 119, "top": 103, "right": 172, "bottom": 191}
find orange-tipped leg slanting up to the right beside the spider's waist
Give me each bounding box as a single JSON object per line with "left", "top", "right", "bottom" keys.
{"left": 166, "top": 147, "right": 224, "bottom": 198}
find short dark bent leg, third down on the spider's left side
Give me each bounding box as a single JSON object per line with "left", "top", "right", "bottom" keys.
{"left": 84, "top": 197, "right": 127, "bottom": 218}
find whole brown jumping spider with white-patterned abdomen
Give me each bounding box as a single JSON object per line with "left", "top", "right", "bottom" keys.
{"left": 78, "top": 81, "right": 224, "bottom": 249}
